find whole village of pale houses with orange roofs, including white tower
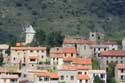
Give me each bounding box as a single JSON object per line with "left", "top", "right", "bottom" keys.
{"left": 0, "top": 26, "right": 125, "bottom": 83}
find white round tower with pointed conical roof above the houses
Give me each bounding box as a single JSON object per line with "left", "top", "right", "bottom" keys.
{"left": 25, "top": 25, "right": 36, "bottom": 44}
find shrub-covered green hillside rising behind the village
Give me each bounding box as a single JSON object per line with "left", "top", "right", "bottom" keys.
{"left": 0, "top": 0, "right": 125, "bottom": 41}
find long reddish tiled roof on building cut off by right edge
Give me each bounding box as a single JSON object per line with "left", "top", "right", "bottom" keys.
{"left": 101, "top": 50, "right": 125, "bottom": 57}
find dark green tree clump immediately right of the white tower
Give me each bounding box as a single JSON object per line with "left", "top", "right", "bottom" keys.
{"left": 33, "top": 29, "right": 64, "bottom": 47}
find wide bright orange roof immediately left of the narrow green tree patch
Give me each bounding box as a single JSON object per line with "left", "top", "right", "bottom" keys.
{"left": 73, "top": 58, "right": 92, "bottom": 65}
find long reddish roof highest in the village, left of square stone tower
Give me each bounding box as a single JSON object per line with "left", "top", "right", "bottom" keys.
{"left": 63, "top": 39, "right": 96, "bottom": 45}
